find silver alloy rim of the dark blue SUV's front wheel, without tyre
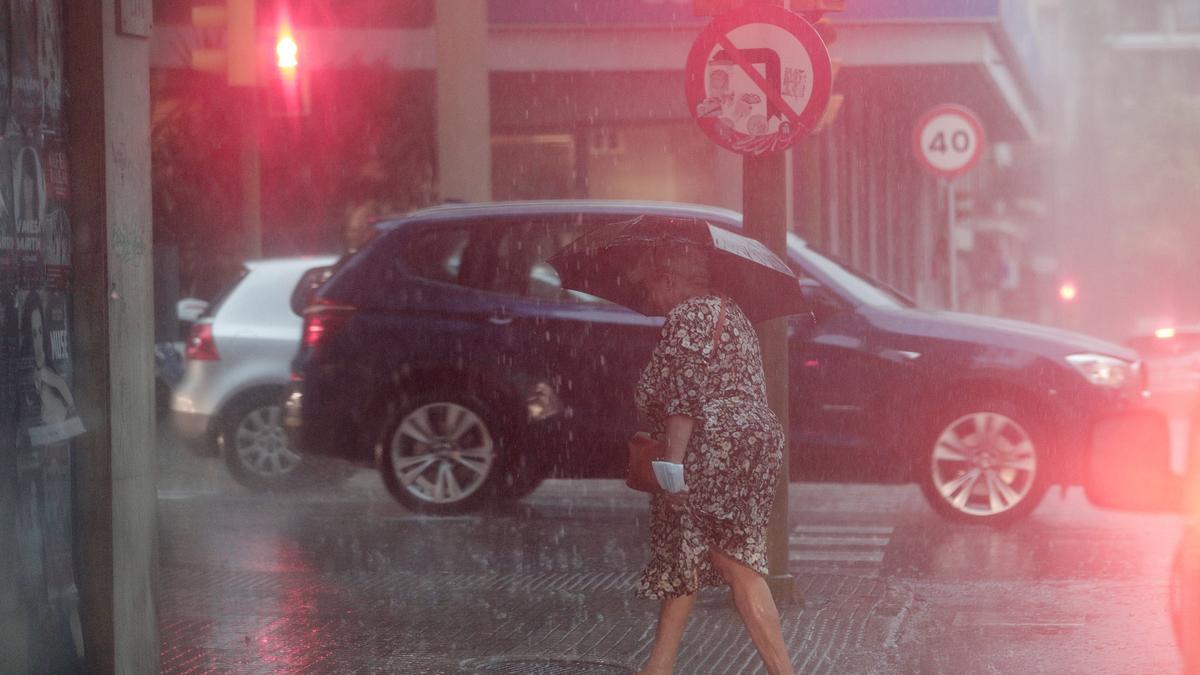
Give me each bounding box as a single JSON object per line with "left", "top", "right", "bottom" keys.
{"left": 931, "top": 412, "right": 1038, "bottom": 518}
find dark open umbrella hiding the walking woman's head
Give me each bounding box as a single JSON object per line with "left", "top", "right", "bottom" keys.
{"left": 547, "top": 216, "right": 805, "bottom": 323}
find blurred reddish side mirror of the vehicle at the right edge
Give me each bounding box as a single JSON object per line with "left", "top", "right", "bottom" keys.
{"left": 1084, "top": 411, "right": 1186, "bottom": 512}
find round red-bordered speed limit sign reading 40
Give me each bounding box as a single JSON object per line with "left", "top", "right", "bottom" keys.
{"left": 912, "top": 106, "right": 988, "bottom": 178}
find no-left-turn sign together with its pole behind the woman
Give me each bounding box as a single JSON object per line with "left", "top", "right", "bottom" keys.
{"left": 685, "top": 0, "right": 833, "bottom": 604}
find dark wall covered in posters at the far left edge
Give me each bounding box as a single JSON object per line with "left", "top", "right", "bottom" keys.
{"left": 0, "top": 0, "right": 85, "bottom": 671}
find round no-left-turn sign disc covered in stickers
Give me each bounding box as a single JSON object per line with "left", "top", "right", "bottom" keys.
{"left": 685, "top": 5, "right": 833, "bottom": 155}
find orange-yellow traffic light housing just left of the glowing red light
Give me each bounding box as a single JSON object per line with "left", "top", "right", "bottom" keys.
{"left": 192, "top": 0, "right": 258, "bottom": 86}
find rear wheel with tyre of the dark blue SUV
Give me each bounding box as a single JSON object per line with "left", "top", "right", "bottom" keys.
{"left": 379, "top": 395, "right": 503, "bottom": 514}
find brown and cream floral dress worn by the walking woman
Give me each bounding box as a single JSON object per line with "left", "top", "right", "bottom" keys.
{"left": 635, "top": 295, "right": 784, "bottom": 598}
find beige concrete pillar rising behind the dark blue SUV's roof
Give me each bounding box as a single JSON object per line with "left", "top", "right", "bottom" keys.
{"left": 434, "top": 0, "right": 492, "bottom": 202}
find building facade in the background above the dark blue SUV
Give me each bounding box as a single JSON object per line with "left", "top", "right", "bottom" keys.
{"left": 147, "top": 0, "right": 1045, "bottom": 318}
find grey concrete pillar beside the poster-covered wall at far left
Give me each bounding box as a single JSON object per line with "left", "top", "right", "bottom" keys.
{"left": 66, "top": 0, "right": 158, "bottom": 673}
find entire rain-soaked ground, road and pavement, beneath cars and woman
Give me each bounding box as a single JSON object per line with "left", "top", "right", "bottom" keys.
{"left": 160, "top": 432, "right": 1181, "bottom": 674}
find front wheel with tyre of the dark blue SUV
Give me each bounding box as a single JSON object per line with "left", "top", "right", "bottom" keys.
{"left": 917, "top": 400, "right": 1048, "bottom": 526}
